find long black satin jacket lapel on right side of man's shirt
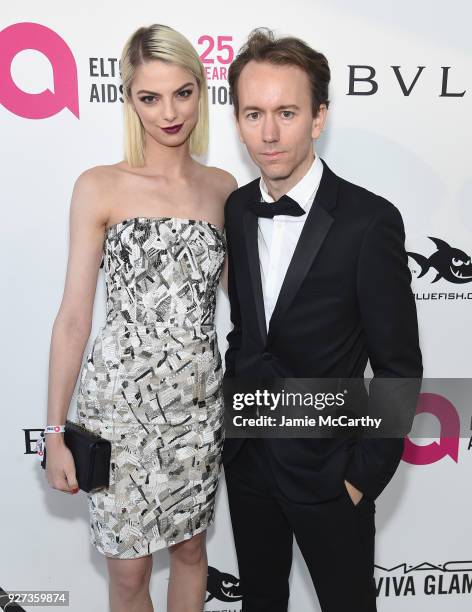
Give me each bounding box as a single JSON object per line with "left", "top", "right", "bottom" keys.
{"left": 268, "top": 160, "right": 338, "bottom": 337}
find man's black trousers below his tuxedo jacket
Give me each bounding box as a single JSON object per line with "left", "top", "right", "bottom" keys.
{"left": 225, "top": 439, "right": 377, "bottom": 612}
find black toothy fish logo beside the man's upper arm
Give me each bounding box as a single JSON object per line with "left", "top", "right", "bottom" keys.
{"left": 408, "top": 236, "right": 472, "bottom": 284}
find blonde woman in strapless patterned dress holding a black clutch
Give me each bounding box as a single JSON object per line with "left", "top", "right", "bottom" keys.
{"left": 42, "top": 25, "right": 237, "bottom": 612}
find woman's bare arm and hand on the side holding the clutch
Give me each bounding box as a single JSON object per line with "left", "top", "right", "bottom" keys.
{"left": 46, "top": 168, "right": 108, "bottom": 492}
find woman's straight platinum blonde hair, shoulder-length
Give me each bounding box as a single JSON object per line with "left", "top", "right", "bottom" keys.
{"left": 120, "top": 23, "right": 208, "bottom": 166}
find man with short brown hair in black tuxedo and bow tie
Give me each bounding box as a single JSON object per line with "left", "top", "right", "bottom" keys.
{"left": 223, "top": 30, "right": 422, "bottom": 612}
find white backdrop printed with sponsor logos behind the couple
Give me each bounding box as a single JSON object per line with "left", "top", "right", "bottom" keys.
{"left": 0, "top": 0, "right": 472, "bottom": 612}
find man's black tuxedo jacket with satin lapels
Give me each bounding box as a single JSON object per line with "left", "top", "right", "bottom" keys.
{"left": 223, "top": 161, "right": 423, "bottom": 503}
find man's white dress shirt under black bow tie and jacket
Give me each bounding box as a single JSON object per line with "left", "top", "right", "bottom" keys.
{"left": 257, "top": 156, "right": 323, "bottom": 328}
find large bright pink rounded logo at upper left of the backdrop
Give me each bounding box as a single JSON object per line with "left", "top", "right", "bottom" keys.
{"left": 0, "top": 22, "right": 79, "bottom": 119}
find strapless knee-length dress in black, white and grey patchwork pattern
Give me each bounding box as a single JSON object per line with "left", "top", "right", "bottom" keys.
{"left": 76, "top": 217, "right": 226, "bottom": 559}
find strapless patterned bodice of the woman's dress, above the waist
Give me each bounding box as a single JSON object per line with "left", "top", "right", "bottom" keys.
{"left": 103, "top": 217, "right": 226, "bottom": 327}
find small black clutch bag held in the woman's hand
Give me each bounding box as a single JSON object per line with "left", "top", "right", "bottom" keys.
{"left": 41, "top": 420, "right": 111, "bottom": 493}
